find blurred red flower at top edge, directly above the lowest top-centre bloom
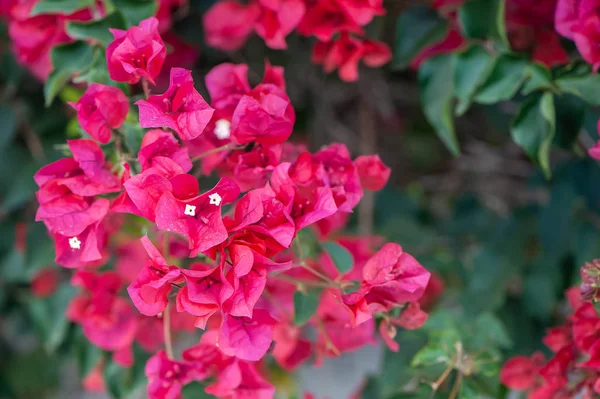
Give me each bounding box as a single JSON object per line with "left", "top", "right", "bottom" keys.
{"left": 298, "top": 0, "right": 365, "bottom": 42}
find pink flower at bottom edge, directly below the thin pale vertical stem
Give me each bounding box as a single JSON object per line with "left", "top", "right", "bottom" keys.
{"left": 145, "top": 350, "right": 208, "bottom": 399}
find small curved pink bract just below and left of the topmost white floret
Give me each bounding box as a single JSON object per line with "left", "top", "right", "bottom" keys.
{"left": 138, "top": 129, "right": 192, "bottom": 173}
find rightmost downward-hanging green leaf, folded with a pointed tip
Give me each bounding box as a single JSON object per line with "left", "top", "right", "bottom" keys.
{"left": 511, "top": 93, "right": 556, "bottom": 177}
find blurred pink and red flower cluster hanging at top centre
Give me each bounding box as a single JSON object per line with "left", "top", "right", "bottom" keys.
{"left": 203, "top": 0, "right": 391, "bottom": 81}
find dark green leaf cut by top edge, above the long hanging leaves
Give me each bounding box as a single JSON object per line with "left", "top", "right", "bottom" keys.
{"left": 458, "top": 0, "right": 509, "bottom": 48}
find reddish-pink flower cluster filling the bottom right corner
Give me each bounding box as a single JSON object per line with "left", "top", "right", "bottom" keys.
{"left": 500, "top": 260, "right": 600, "bottom": 399}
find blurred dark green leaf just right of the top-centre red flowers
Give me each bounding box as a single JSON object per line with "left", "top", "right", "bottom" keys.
{"left": 393, "top": 5, "right": 448, "bottom": 68}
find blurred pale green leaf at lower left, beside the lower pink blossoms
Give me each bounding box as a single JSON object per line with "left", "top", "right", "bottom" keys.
{"left": 28, "top": 284, "right": 76, "bottom": 353}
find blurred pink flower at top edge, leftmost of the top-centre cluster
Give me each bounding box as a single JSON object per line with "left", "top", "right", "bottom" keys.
{"left": 202, "top": 0, "right": 260, "bottom": 51}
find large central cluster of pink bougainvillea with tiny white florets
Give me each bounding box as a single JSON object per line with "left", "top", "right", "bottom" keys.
{"left": 29, "top": 16, "right": 441, "bottom": 399}
